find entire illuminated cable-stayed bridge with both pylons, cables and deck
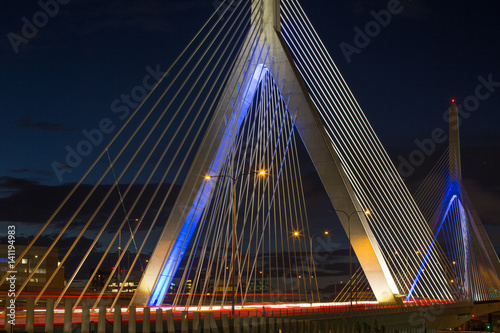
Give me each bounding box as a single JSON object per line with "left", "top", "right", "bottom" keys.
{"left": 2, "top": 0, "right": 500, "bottom": 330}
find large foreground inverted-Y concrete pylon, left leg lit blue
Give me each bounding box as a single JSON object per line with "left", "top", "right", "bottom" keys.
{"left": 132, "top": 0, "right": 399, "bottom": 305}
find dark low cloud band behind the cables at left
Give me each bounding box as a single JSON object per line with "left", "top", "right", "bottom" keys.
{"left": 0, "top": 177, "right": 179, "bottom": 231}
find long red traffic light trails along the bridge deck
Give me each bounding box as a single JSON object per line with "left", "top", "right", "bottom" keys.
{"left": 0, "top": 298, "right": 470, "bottom": 332}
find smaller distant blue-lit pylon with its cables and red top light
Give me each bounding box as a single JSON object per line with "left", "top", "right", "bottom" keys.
{"left": 418, "top": 101, "right": 500, "bottom": 301}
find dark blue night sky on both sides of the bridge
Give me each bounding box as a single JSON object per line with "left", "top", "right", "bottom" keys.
{"left": 0, "top": 0, "right": 500, "bottom": 252}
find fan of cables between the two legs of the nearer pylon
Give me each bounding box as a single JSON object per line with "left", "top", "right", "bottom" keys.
{"left": 167, "top": 69, "right": 319, "bottom": 307}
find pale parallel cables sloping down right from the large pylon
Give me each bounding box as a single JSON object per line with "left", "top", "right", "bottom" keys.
{"left": 281, "top": 0, "right": 454, "bottom": 300}
